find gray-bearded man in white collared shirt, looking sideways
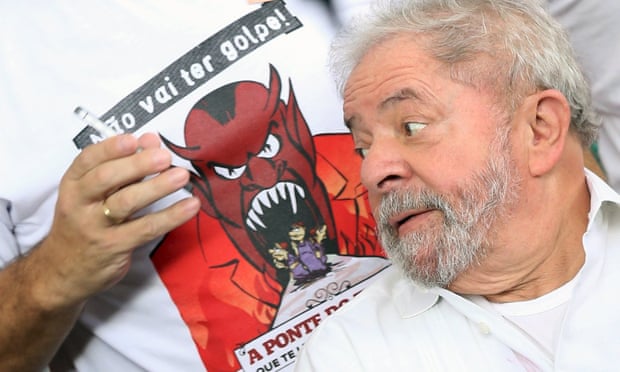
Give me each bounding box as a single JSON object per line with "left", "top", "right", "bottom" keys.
{"left": 297, "top": 0, "right": 620, "bottom": 371}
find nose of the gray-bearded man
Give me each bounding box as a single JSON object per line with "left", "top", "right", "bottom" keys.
{"left": 360, "top": 137, "right": 413, "bottom": 194}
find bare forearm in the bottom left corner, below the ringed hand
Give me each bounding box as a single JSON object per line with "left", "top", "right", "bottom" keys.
{"left": 0, "top": 244, "right": 83, "bottom": 371}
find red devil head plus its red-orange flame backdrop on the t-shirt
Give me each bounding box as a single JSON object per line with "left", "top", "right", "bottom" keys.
{"left": 152, "top": 66, "right": 380, "bottom": 371}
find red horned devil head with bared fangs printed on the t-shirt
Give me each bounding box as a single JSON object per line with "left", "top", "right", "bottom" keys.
{"left": 164, "top": 66, "right": 336, "bottom": 285}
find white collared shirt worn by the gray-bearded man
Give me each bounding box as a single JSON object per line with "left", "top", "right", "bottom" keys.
{"left": 296, "top": 170, "right": 620, "bottom": 372}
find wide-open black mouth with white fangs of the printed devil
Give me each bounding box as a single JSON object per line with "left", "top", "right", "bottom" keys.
{"left": 245, "top": 181, "right": 322, "bottom": 246}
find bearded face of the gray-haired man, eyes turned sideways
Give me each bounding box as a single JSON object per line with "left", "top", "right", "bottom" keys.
{"left": 344, "top": 36, "right": 519, "bottom": 287}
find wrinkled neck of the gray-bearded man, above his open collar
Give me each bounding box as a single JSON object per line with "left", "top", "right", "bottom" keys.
{"left": 449, "top": 175, "right": 590, "bottom": 303}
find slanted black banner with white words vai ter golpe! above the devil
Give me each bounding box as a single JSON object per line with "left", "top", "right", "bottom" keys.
{"left": 73, "top": 0, "right": 302, "bottom": 149}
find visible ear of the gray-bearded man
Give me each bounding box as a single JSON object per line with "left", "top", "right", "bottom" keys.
{"left": 522, "top": 89, "right": 571, "bottom": 176}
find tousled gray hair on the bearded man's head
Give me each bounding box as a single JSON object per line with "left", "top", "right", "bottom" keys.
{"left": 330, "top": 0, "right": 599, "bottom": 147}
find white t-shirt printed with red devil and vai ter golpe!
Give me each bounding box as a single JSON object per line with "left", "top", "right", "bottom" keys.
{"left": 0, "top": 0, "right": 387, "bottom": 371}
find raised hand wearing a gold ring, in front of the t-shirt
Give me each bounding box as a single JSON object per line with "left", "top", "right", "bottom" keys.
{"left": 33, "top": 134, "right": 200, "bottom": 308}
